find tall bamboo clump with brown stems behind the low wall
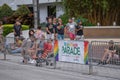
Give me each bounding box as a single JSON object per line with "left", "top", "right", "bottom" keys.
{"left": 62, "top": 0, "right": 120, "bottom": 25}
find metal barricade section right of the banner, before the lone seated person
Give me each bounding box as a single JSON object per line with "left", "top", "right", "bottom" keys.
{"left": 89, "top": 41, "right": 120, "bottom": 80}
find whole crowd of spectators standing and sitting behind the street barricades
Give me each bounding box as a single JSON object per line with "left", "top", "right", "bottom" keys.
{"left": 0, "top": 17, "right": 119, "bottom": 64}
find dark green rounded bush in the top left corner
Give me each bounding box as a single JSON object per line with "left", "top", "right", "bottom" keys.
{"left": 0, "top": 4, "right": 13, "bottom": 18}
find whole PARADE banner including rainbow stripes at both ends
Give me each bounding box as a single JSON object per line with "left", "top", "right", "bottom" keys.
{"left": 54, "top": 40, "right": 88, "bottom": 64}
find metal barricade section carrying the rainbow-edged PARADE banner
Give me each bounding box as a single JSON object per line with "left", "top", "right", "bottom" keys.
{"left": 54, "top": 40, "right": 89, "bottom": 73}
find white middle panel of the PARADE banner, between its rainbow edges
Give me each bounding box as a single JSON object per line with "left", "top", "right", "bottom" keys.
{"left": 58, "top": 41, "right": 84, "bottom": 64}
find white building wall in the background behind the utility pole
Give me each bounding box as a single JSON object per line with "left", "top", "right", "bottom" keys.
{"left": 0, "top": 0, "right": 64, "bottom": 23}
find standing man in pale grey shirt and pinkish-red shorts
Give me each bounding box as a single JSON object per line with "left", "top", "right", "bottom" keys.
{"left": 66, "top": 18, "right": 76, "bottom": 40}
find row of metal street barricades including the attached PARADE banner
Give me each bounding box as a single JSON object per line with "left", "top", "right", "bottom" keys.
{"left": 0, "top": 38, "right": 120, "bottom": 79}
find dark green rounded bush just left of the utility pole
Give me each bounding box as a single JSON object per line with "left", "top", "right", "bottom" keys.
{"left": 14, "top": 5, "right": 30, "bottom": 16}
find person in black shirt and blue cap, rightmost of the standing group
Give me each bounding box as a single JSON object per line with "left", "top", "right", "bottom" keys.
{"left": 76, "top": 20, "right": 84, "bottom": 40}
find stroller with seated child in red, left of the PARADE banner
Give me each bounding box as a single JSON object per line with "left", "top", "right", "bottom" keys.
{"left": 36, "top": 40, "right": 54, "bottom": 67}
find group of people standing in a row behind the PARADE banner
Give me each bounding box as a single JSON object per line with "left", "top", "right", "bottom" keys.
{"left": 46, "top": 18, "right": 84, "bottom": 40}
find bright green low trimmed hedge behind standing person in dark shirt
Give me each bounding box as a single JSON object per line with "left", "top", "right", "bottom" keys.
{"left": 3, "top": 24, "right": 29, "bottom": 36}
